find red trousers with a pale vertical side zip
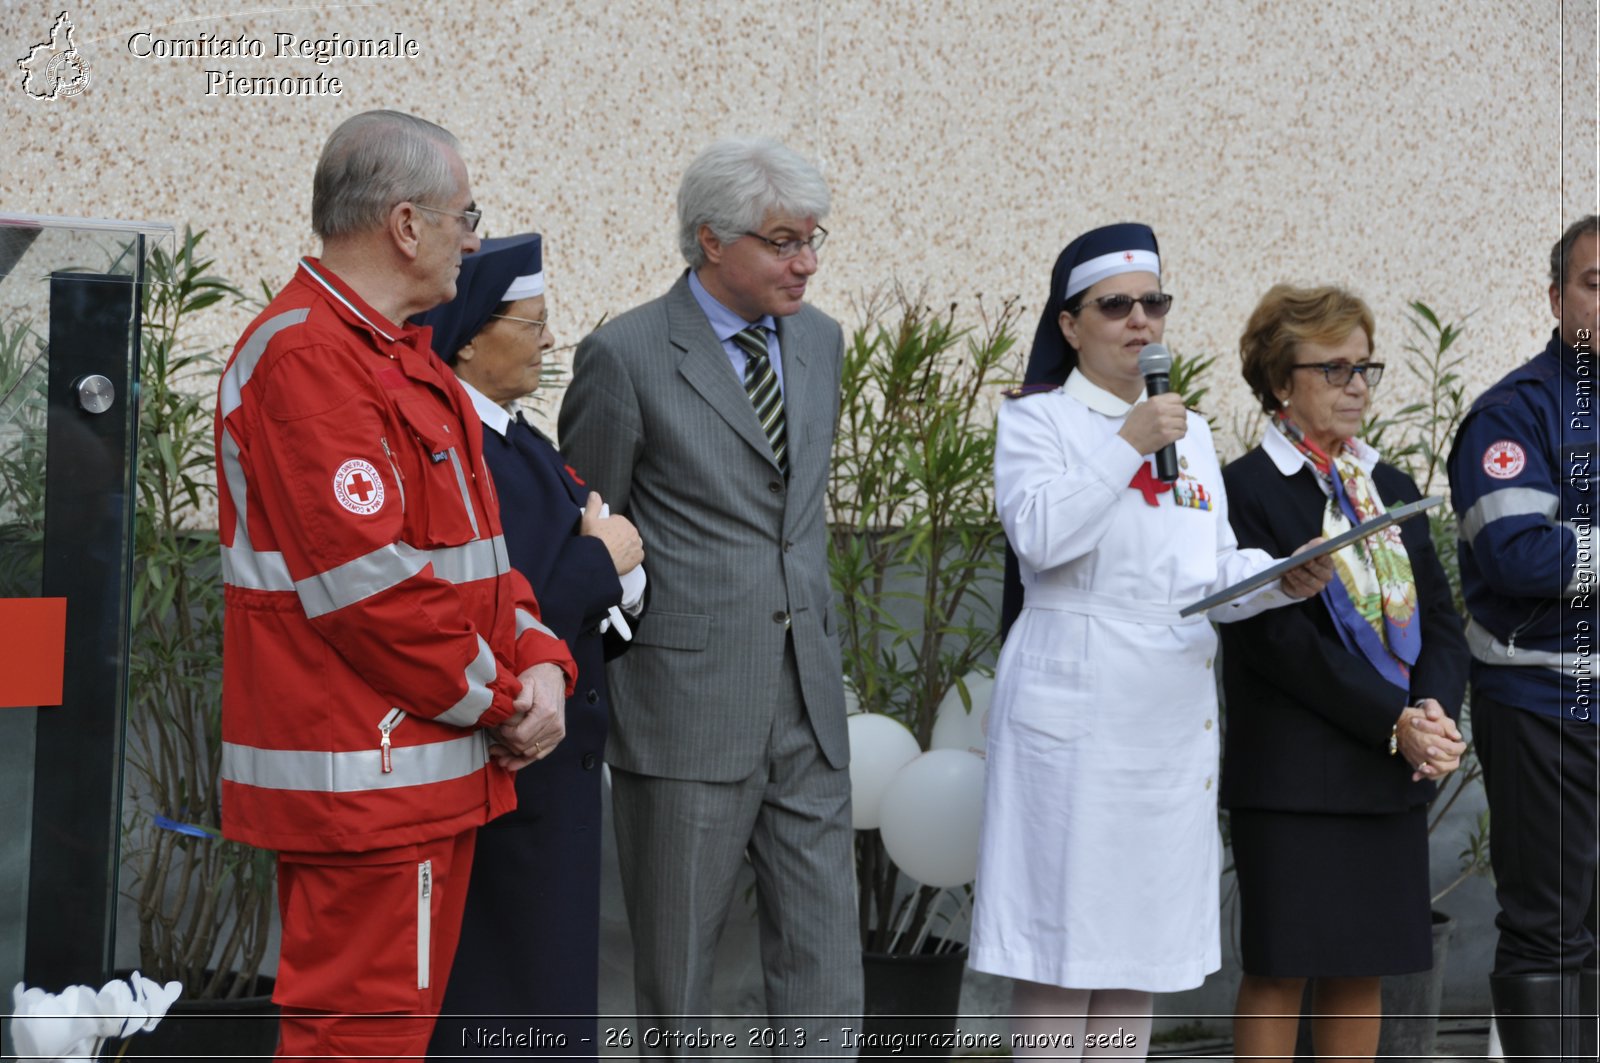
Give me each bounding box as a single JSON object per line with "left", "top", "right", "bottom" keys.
{"left": 272, "top": 829, "right": 477, "bottom": 1063}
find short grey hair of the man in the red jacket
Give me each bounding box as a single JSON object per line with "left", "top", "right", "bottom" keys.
{"left": 310, "top": 110, "right": 459, "bottom": 240}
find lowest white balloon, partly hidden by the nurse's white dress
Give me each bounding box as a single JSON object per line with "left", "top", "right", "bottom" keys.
{"left": 878, "top": 749, "right": 984, "bottom": 889}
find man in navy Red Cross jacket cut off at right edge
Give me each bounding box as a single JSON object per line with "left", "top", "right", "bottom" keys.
{"left": 1450, "top": 215, "right": 1600, "bottom": 1060}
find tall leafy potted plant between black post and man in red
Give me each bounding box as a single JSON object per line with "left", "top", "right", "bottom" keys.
{"left": 123, "top": 229, "right": 274, "bottom": 1052}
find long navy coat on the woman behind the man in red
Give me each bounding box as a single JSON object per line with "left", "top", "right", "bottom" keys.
{"left": 432, "top": 421, "right": 634, "bottom": 1058}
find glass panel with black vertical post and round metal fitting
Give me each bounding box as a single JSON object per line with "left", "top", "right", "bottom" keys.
{"left": 0, "top": 213, "right": 171, "bottom": 989}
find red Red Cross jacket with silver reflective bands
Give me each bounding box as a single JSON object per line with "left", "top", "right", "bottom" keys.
{"left": 216, "top": 258, "right": 576, "bottom": 852}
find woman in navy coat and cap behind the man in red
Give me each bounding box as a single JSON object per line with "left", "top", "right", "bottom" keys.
{"left": 418, "top": 234, "right": 645, "bottom": 1058}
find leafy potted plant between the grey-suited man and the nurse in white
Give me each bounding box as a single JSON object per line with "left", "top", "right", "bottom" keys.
{"left": 827, "top": 293, "right": 1019, "bottom": 1037}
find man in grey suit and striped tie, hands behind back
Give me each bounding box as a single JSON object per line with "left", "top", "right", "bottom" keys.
{"left": 560, "top": 139, "right": 861, "bottom": 1055}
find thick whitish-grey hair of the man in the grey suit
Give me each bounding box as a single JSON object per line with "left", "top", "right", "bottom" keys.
{"left": 678, "top": 136, "right": 829, "bottom": 269}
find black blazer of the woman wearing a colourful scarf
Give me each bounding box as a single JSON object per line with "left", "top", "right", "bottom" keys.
{"left": 1219, "top": 447, "right": 1469, "bottom": 813}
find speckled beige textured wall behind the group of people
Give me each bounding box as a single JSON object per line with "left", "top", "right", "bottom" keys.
{"left": 0, "top": 0, "right": 1597, "bottom": 451}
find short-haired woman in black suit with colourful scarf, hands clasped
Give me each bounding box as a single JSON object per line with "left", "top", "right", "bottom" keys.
{"left": 1221, "top": 285, "right": 1467, "bottom": 1058}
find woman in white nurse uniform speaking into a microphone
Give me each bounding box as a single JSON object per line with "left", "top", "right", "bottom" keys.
{"left": 970, "top": 224, "right": 1331, "bottom": 1058}
